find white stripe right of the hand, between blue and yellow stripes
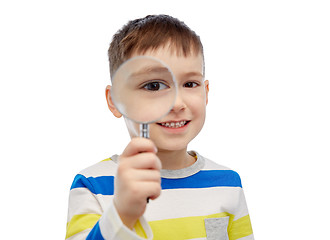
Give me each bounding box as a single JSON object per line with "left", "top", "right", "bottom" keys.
{"left": 145, "top": 187, "right": 248, "bottom": 221}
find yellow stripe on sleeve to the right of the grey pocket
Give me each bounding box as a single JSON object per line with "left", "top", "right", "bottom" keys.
{"left": 229, "top": 215, "right": 253, "bottom": 240}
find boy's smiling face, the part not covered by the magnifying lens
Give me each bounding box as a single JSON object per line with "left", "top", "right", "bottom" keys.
{"left": 110, "top": 47, "right": 209, "bottom": 151}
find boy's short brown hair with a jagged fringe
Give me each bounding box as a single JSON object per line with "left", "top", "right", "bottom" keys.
{"left": 108, "top": 15, "right": 204, "bottom": 76}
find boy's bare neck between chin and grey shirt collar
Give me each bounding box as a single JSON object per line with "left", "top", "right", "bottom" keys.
{"left": 157, "top": 148, "right": 196, "bottom": 170}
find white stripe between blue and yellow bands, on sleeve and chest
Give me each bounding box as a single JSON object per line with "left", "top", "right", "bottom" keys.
{"left": 68, "top": 187, "right": 248, "bottom": 221}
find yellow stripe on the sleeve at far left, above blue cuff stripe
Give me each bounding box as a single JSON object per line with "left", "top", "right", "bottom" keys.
{"left": 65, "top": 214, "right": 101, "bottom": 239}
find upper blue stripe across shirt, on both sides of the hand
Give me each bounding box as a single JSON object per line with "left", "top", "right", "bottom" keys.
{"left": 71, "top": 170, "right": 242, "bottom": 195}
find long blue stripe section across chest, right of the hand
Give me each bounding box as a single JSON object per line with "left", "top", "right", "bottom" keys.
{"left": 162, "top": 170, "right": 242, "bottom": 189}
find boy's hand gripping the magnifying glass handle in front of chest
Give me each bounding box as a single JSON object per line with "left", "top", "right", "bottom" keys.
{"left": 114, "top": 138, "right": 161, "bottom": 229}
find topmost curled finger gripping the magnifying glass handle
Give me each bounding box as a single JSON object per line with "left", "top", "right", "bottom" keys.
{"left": 122, "top": 137, "right": 157, "bottom": 157}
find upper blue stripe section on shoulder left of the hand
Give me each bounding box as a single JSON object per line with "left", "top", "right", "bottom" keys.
{"left": 71, "top": 174, "right": 114, "bottom": 195}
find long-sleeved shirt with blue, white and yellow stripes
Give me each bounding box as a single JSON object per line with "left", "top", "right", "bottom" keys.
{"left": 66, "top": 152, "right": 254, "bottom": 240}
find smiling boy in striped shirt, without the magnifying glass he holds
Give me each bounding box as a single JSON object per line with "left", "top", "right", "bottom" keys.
{"left": 66, "top": 15, "right": 253, "bottom": 240}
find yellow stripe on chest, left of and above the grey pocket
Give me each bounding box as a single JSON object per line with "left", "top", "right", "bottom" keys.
{"left": 149, "top": 212, "right": 233, "bottom": 240}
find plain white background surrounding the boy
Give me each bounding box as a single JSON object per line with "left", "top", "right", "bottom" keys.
{"left": 0, "top": 0, "right": 330, "bottom": 240}
